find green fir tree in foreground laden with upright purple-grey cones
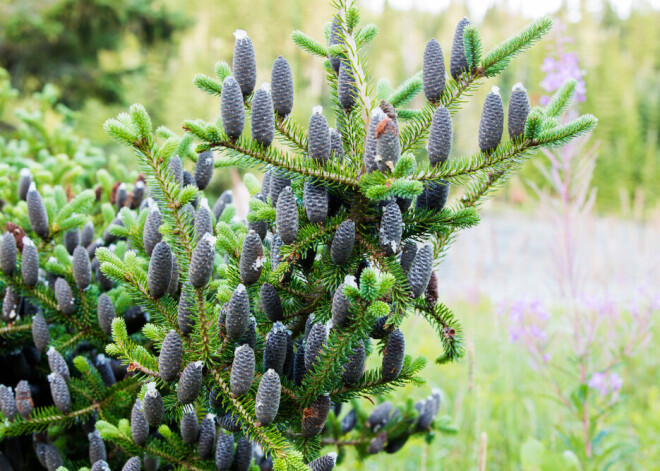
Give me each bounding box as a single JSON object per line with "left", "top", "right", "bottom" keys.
{"left": 0, "top": 0, "right": 596, "bottom": 471}
